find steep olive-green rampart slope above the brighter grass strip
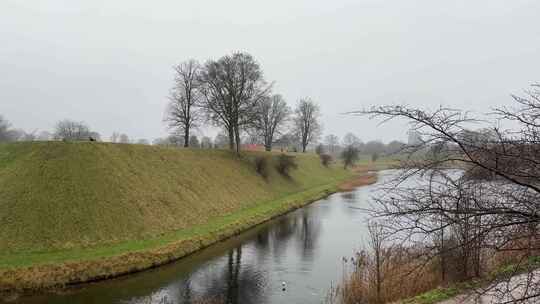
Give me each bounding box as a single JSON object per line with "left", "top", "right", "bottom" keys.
{"left": 0, "top": 142, "right": 348, "bottom": 253}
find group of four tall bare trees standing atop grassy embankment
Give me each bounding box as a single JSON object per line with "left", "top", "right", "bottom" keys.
{"left": 165, "top": 52, "right": 322, "bottom": 153}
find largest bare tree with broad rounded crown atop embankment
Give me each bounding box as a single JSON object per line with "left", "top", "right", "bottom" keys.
{"left": 200, "top": 53, "right": 270, "bottom": 153}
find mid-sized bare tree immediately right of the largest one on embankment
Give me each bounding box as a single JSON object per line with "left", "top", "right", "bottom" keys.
{"left": 251, "top": 94, "right": 291, "bottom": 151}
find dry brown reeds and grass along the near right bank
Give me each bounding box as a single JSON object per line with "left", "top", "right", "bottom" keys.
{"left": 334, "top": 240, "right": 540, "bottom": 304}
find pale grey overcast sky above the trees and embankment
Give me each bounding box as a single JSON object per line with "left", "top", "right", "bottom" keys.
{"left": 0, "top": 0, "right": 540, "bottom": 141}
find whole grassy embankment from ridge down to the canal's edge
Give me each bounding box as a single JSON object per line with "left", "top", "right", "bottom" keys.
{"left": 0, "top": 142, "right": 388, "bottom": 291}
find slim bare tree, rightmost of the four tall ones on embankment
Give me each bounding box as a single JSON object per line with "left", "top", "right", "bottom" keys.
{"left": 293, "top": 97, "right": 322, "bottom": 153}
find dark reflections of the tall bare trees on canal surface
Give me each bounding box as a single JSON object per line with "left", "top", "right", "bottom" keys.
{"left": 195, "top": 210, "right": 321, "bottom": 304}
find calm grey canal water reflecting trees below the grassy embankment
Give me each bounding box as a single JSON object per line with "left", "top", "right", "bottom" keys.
{"left": 13, "top": 171, "right": 394, "bottom": 304}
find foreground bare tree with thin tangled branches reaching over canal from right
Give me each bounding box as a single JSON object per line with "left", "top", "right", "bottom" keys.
{"left": 350, "top": 85, "right": 540, "bottom": 303}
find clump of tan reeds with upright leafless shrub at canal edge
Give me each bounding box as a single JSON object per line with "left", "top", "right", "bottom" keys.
{"left": 338, "top": 224, "right": 441, "bottom": 304}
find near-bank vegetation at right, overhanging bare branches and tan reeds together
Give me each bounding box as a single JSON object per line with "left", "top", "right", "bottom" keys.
{"left": 331, "top": 85, "right": 540, "bottom": 303}
